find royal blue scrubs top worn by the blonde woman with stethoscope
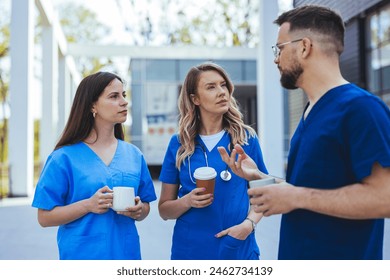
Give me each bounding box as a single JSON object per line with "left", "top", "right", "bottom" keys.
{"left": 160, "top": 133, "right": 267, "bottom": 260}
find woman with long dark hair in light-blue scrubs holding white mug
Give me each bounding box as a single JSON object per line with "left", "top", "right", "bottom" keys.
{"left": 32, "top": 72, "right": 156, "bottom": 260}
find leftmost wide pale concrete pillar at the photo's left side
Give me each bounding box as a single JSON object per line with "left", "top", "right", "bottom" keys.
{"left": 8, "top": 0, "right": 34, "bottom": 196}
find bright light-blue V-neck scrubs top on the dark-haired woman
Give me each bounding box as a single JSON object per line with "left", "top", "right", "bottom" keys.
{"left": 32, "top": 140, "right": 156, "bottom": 260}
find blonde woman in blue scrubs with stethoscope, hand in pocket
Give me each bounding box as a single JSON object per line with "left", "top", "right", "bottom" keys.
{"left": 159, "top": 63, "right": 267, "bottom": 259}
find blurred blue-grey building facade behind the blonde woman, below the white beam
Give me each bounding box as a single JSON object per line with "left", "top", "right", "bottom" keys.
{"left": 130, "top": 58, "right": 257, "bottom": 166}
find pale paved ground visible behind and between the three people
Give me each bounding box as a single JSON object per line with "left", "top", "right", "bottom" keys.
{"left": 0, "top": 181, "right": 390, "bottom": 260}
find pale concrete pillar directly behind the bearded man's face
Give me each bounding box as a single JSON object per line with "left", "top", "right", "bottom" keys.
{"left": 257, "top": 0, "right": 285, "bottom": 178}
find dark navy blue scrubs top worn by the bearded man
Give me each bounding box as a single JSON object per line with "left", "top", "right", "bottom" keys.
{"left": 279, "top": 84, "right": 390, "bottom": 259}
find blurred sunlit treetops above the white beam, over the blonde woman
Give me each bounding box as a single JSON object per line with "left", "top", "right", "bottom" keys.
{"left": 127, "top": 0, "right": 259, "bottom": 47}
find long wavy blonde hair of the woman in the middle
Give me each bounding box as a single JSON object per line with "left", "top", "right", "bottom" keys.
{"left": 176, "top": 62, "right": 256, "bottom": 169}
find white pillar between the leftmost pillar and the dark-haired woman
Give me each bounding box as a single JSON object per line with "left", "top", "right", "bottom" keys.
{"left": 39, "top": 26, "right": 58, "bottom": 164}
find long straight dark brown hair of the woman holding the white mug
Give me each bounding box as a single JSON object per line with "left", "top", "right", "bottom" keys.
{"left": 55, "top": 72, "right": 124, "bottom": 150}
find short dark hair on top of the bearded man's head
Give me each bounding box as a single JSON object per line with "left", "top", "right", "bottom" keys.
{"left": 274, "top": 5, "right": 345, "bottom": 55}
